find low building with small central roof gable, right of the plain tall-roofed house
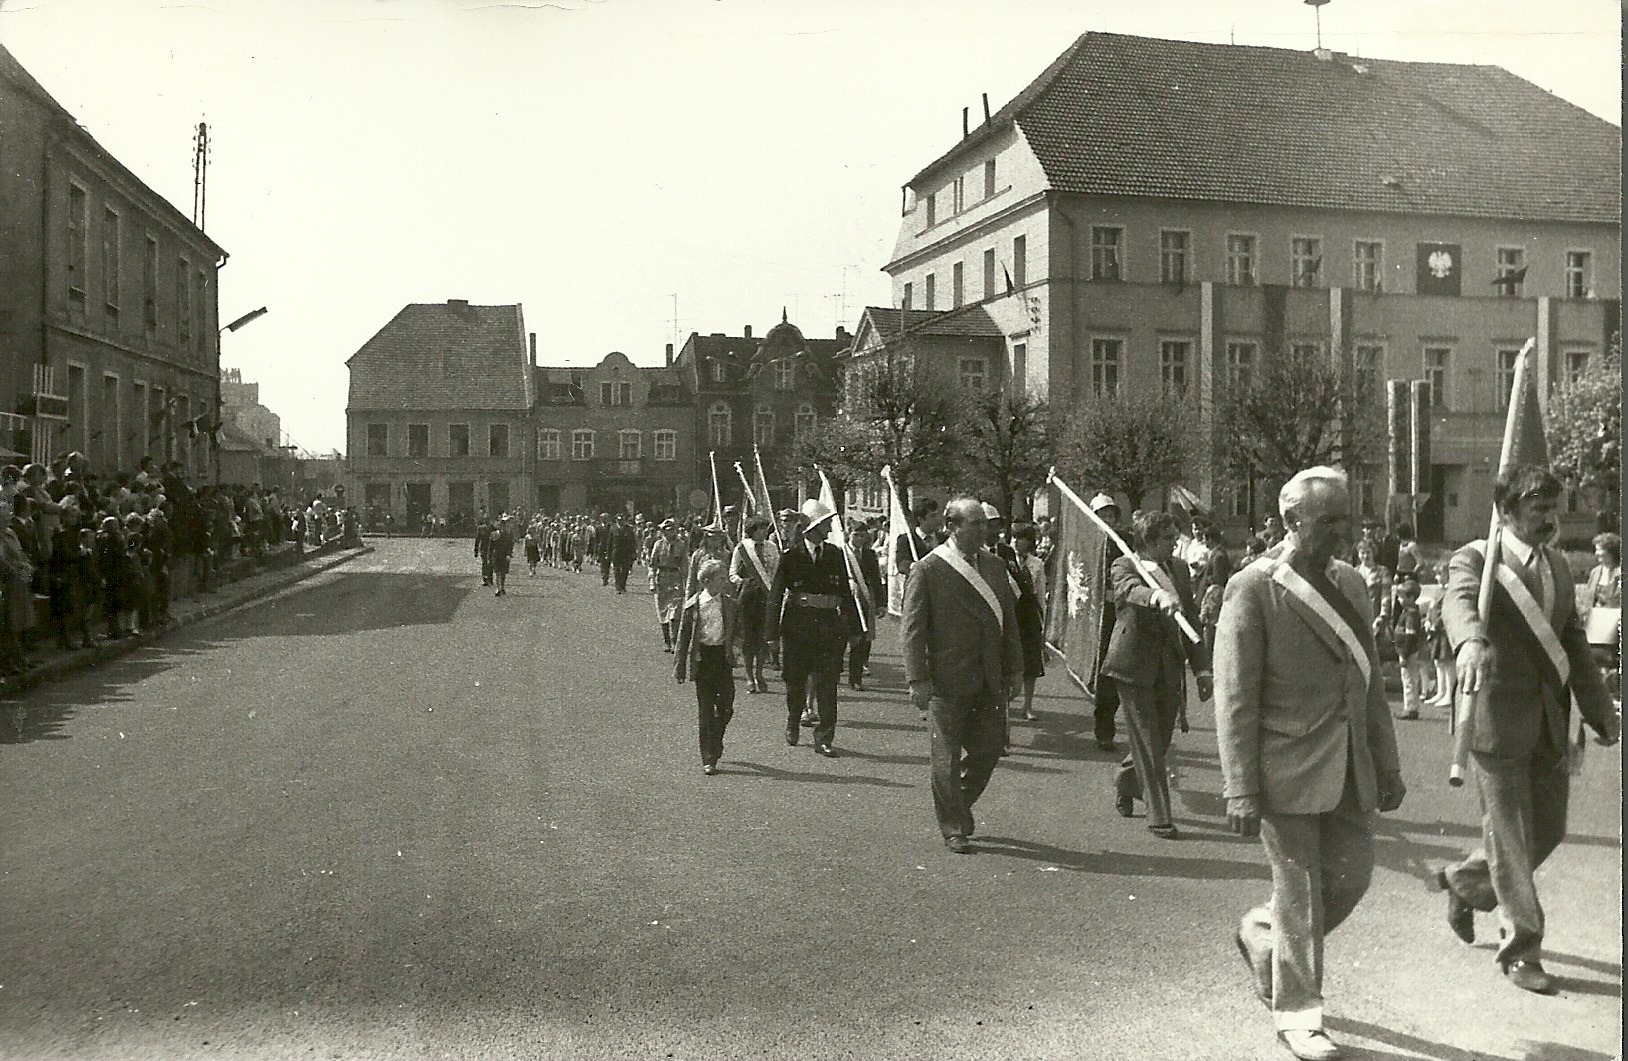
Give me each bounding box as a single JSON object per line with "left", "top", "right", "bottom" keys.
{"left": 532, "top": 350, "right": 695, "bottom": 516}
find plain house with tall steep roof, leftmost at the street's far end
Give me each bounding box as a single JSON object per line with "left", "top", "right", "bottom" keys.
{"left": 345, "top": 299, "right": 536, "bottom": 531}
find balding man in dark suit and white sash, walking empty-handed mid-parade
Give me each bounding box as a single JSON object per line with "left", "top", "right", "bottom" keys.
{"left": 900, "top": 498, "right": 1022, "bottom": 854}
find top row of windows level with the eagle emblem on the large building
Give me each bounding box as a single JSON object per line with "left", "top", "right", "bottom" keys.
{"left": 1091, "top": 225, "right": 1594, "bottom": 298}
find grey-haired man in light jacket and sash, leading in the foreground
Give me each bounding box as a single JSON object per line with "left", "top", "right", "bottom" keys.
{"left": 1214, "top": 467, "right": 1407, "bottom": 1061}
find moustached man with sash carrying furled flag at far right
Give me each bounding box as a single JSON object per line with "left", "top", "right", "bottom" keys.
{"left": 1436, "top": 465, "right": 1621, "bottom": 994}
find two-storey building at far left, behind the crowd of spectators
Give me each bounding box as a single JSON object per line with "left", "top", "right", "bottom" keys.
{"left": 0, "top": 40, "right": 226, "bottom": 477}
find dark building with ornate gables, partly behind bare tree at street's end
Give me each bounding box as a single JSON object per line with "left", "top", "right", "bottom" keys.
{"left": 672, "top": 309, "right": 851, "bottom": 504}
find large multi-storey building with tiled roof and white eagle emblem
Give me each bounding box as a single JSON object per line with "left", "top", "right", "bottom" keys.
{"left": 886, "top": 33, "right": 1621, "bottom": 540}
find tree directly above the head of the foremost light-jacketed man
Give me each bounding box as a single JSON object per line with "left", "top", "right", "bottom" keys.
{"left": 1214, "top": 347, "right": 1384, "bottom": 501}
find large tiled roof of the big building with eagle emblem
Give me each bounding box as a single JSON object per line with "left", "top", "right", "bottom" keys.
{"left": 912, "top": 33, "right": 1621, "bottom": 225}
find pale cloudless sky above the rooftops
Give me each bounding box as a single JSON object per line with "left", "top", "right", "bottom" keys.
{"left": 0, "top": 0, "right": 1621, "bottom": 452}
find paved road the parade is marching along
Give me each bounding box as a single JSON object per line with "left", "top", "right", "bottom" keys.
{"left": 0, "top": 540, "right": 1621, "bottom": 1061}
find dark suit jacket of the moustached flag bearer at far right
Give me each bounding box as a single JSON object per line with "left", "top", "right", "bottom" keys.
{"left": 1441, "top": 542, "right": 1613, "bottom": 757}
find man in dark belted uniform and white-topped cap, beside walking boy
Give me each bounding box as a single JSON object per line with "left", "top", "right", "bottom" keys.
{"left": 765, "top": 498, "right": 858, "bottom": 758}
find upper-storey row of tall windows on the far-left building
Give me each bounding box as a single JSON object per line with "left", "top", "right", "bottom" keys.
{"left": 67, "top": 184, "right": 208, "bottom": 353}
